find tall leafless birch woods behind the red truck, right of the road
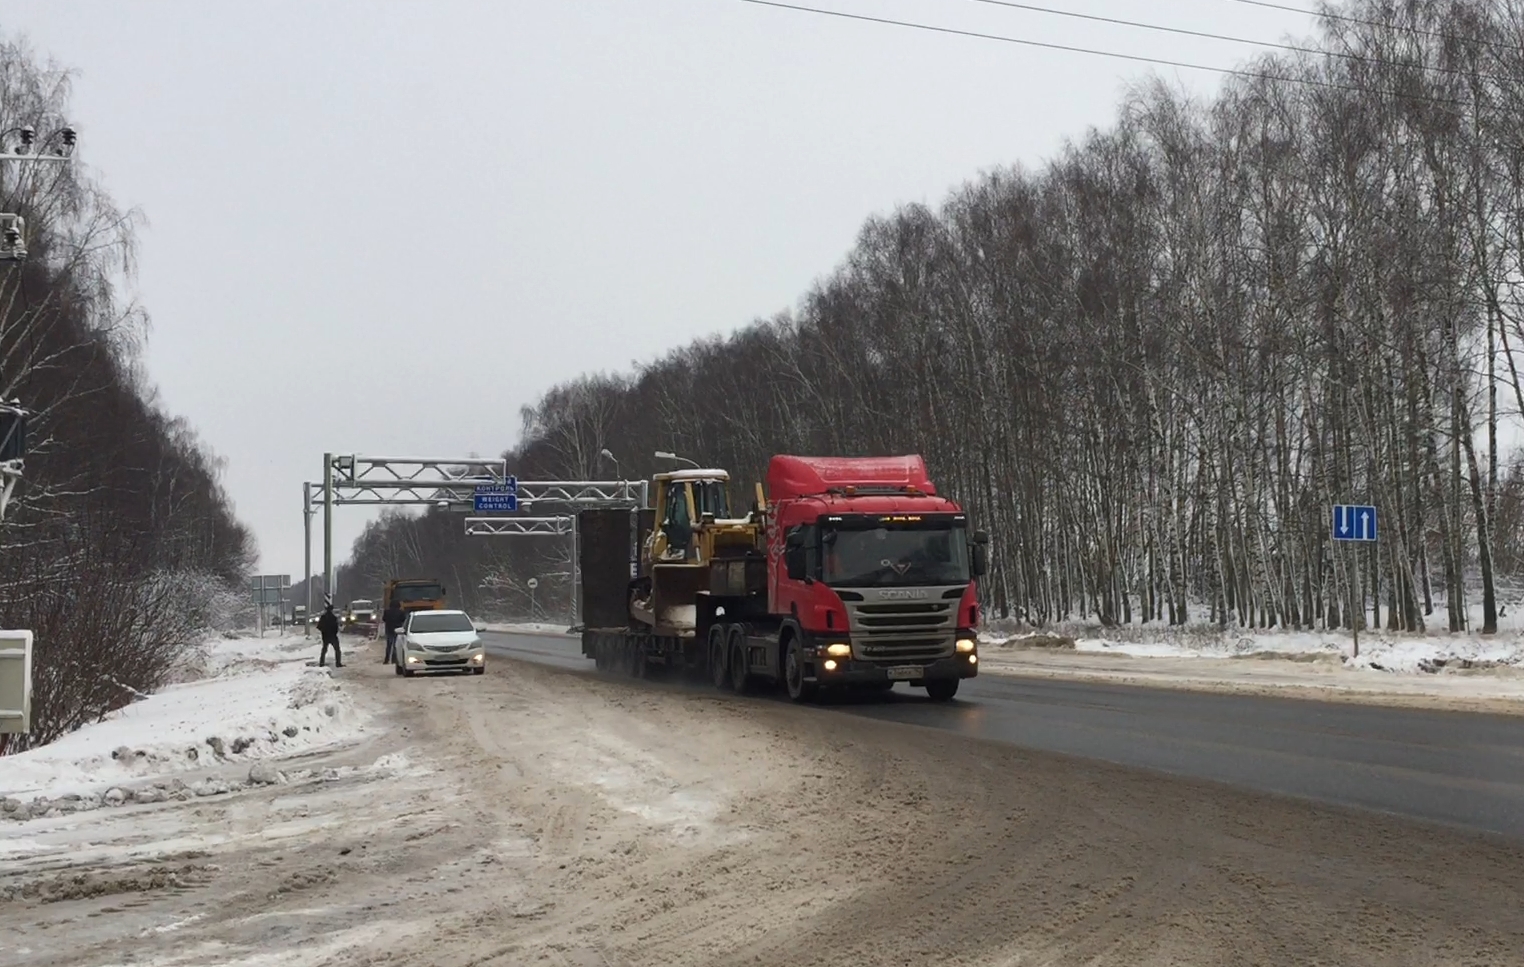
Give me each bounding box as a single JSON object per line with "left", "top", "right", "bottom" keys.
{"left": 339, "top": 0, "right": 1524, "bottom": 632}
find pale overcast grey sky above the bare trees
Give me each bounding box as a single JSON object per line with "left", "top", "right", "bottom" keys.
{"left": 0, "top": 0, "right": 1314, "bottom": 574}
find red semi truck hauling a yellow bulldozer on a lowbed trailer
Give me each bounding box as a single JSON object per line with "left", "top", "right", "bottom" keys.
{"left": 579, "top": 455, "right": 988, "bottom": 701}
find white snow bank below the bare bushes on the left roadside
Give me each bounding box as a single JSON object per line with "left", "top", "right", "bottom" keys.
{"left": 0, "top": 635, "right": 370, "bottom": 798}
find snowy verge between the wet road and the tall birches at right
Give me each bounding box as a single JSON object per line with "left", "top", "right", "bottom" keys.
{"left": 980, "top": 627, "right": 1524, "bottom": 714}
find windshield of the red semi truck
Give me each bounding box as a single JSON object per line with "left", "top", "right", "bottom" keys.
{"left": 820, "top": 524, "right": 969, "bottom": 588}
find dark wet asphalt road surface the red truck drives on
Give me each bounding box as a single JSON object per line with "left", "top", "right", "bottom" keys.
{"left": 483, "top": 633, "right": 1524, "bottom": 839}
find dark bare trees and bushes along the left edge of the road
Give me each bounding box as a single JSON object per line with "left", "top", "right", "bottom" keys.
{"left": 0, "top": 38, "right": 255, "bottom": 752}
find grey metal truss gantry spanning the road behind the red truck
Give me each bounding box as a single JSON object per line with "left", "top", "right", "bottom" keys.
{"left": 302, "top": 452, "right": 649, "bottom": 633}
